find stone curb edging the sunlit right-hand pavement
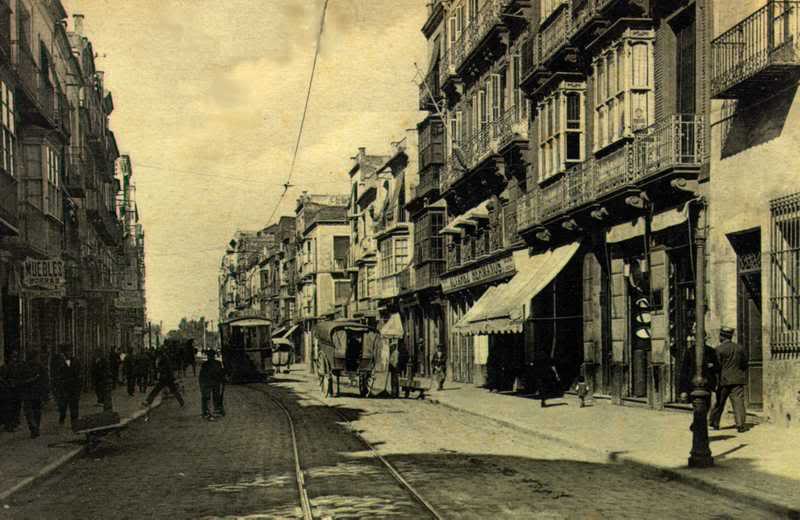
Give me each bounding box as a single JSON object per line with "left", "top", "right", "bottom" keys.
{"left": 425, "top": 396, "right": 800, "bottom": 520}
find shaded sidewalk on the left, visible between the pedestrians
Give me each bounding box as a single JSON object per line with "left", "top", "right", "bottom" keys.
{"left": 0, "top": 375, "right": 196, "bottom": 507}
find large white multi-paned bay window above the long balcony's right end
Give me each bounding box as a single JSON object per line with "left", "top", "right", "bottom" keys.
{"left": 593, "top": 32, "right": 655, "bottom": 151}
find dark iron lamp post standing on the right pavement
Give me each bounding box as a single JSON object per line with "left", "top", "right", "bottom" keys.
{"left": 689, "top": 198, "right": 714, "bottom": 468}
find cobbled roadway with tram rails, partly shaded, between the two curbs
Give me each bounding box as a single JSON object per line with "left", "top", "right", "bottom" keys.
{"left": 0, "top": 370, "right": 769, "bottom": 519}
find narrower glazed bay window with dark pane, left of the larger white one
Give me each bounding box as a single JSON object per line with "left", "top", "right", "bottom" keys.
{"left": 538, "top": 82, "right": 586, "bottom": 181}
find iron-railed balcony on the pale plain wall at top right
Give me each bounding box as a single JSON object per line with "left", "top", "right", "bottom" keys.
{"left": 711, "top": 0, "right": 800, "bottom": 99}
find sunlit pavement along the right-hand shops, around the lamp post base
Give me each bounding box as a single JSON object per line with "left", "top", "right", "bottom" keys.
{"left": 412, "top": 382, "right": 800, "bottom": 518}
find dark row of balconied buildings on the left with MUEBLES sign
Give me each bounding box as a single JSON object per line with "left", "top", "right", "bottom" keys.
{"left": 0, "top": 0, "right": 145, "bottom": 382}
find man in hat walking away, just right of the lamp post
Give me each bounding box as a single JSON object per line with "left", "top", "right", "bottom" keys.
{"left": 711, "top": 327, "right": 747, "bottom": 432}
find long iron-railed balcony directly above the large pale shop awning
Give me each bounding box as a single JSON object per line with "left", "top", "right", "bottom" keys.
{"left": 517, "top": 114, "right": 706, "bottom": 232}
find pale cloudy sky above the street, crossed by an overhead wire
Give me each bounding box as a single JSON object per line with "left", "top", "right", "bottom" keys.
{"left": 62, "top": 0, "right": 427, "bottom": 330}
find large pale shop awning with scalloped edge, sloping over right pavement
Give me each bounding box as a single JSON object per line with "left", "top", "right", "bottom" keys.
{"left": 453, "top": 242, "right": 580, "bottom": 335}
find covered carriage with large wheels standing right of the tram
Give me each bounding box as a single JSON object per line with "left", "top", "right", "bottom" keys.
{"left": 314, "top": 320, "right": 381, "bottom": 397}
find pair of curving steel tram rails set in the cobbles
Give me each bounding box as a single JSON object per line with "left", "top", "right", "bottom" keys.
{"left": 248, "top": 385, "right": 445, "bottom": 520}
